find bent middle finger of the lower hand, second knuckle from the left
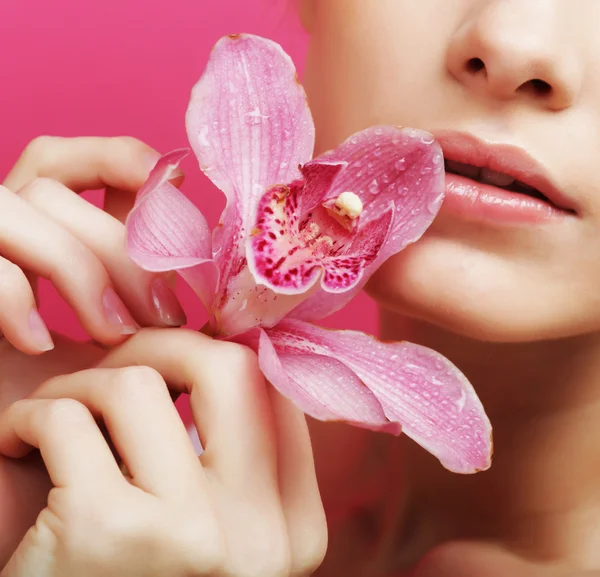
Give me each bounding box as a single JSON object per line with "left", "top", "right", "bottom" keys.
{"left": 34, "top": 366, "right": 206, "bottom": 498}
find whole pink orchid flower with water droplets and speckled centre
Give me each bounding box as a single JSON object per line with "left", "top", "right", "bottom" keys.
{"left": 127, "top": 35, "right": 492, "bottom": 473}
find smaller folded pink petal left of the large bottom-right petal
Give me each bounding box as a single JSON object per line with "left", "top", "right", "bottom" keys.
{"left": 235, "top": 329, "right": 400, "bottom": 434}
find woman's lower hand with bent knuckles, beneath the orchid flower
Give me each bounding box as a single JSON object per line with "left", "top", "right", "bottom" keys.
{"left": 0, "top": 329, "right": 326, "bottom": 577}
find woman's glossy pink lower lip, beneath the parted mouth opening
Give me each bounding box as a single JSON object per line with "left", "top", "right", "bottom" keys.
{"left": 442, "top": 173, "right": 573, "bottom": 224}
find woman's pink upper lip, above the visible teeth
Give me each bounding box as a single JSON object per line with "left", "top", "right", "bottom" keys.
{"left": 433, "top": 131, "right": 576, "bottom": 212}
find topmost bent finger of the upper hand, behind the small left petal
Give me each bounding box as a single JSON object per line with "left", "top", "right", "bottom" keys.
{"left": 4, "top": 136, "right": 182, "bottom": 198}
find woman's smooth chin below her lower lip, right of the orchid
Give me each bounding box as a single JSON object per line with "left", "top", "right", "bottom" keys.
{"left": 366, "top": 235, "right": 600, "bottom": 343}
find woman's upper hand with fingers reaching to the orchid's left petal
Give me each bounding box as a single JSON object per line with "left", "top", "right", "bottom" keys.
{"left": 0, "top": 137, "right": 185, "bottom": 354}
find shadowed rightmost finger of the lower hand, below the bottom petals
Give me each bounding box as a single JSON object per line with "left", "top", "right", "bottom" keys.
{"left": 269, "top": 387, "right": 327, "bottom": 577}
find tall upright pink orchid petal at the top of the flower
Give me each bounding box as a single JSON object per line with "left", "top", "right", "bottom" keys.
{"left": 186, "top": 35, "right": 314, "bottom": 294}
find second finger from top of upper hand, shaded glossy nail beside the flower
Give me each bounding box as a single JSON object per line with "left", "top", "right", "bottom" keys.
{"left": 19, "top": 179, "right": 186, "bottom": 326}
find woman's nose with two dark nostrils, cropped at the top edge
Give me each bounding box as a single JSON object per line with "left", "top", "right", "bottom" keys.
{"left": 447, "top": 0, "right": 582, "bottom": 110}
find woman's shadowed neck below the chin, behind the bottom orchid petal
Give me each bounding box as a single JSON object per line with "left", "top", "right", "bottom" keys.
{"left": 382, "top": 311, "right": 600, "bottom": 566}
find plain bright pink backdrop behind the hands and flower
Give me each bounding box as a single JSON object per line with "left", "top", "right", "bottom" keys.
{"left": 0, "top": 0, "right": 376, "bottom": 337}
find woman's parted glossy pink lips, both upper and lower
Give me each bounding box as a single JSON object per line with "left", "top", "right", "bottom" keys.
{"left": 432, "top": 131, "right": 577, "bottom": 222}
